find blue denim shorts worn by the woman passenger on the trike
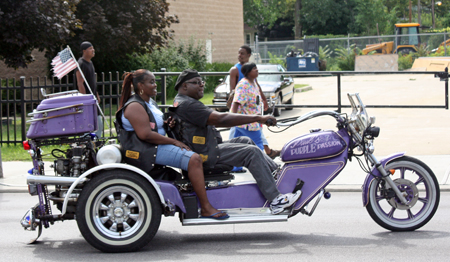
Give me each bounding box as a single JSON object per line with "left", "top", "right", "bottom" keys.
{"left": 155, "top": 145, "right": 195, "bottom": 171}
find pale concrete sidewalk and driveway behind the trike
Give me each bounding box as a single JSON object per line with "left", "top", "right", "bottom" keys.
{"left": 0, "top": 75, "right": 450, "bottom": 193}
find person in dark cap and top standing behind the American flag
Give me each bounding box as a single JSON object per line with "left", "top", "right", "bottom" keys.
{"left": 75, "top": 41, "right": 103, "bottom": 137}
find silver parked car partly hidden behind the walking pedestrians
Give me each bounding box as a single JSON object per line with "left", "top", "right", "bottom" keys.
{"left": 213, "top": 64, "right": 294, "bottom": 116}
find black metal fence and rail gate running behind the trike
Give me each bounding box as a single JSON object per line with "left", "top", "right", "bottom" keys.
{"left": 0, "top": 71, "right": 449, "bottom": 144}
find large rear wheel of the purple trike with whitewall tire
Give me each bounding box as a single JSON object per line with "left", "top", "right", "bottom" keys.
{"left": 76, "top": 170, "right": 162, "bottom": 253}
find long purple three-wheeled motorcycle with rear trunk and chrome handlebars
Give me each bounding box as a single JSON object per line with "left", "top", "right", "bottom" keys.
{"left": 21, "top": 92, "right": 440, "bottom": 252}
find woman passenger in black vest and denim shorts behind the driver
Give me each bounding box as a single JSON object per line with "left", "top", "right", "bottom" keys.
{"left": 116, "top": 69, "right": 229, "bottom": 219}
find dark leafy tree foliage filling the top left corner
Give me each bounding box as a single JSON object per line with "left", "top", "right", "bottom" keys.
{"left": 0, "top": 0, "right": 178, "bottom": 72}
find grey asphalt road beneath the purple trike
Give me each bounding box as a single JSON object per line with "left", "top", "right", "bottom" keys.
{"left": 0, "top": 192, "right": 450, "bottom": 262}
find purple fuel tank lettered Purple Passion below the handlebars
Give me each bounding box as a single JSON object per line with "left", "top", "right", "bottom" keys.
{"left": 281, "top": 130, "right": 347, "bottom": 162}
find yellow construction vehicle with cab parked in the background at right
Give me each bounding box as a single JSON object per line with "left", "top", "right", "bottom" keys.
{"left": 362, "top": 23, "right": 420, "bottom": 55}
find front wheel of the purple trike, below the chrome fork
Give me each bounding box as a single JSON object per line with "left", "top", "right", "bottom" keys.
{"left": 366, "top": 156, "right": 440, "bottom": 231}
